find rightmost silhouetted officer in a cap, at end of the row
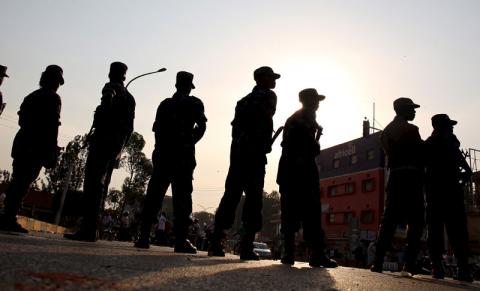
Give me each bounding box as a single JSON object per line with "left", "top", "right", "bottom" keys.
{"left": 425, "top": 114, "right": 473, "bottom": 282}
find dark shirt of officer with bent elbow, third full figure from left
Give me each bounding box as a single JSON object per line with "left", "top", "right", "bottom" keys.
{"left": 152, "top": 92, "right": 207, "bottom": 155}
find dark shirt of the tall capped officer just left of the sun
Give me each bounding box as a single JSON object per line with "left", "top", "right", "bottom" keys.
{"left": 231, "top": 86, "right": 277, "bottom": 162}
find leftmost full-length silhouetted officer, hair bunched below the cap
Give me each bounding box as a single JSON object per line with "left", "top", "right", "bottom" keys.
{"left": 0, "top": 65, "right": 64, "bottom": 233}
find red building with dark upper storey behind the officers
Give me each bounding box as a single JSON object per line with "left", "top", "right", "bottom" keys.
{"left": 317, "top": 132, "right": 385, "bottom": 251}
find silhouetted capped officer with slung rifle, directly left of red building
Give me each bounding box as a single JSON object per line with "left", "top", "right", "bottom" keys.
{"left": 277, "top": 88, "right": 337, "bottom": 268}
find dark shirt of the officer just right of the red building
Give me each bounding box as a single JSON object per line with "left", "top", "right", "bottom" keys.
{"left": 380, "top": 116, "right": 424, "bottom": 169}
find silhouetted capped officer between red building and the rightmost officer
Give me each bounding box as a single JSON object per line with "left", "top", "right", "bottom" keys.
{"left": 371, "top": 97, "right": 425, "bottom": 276}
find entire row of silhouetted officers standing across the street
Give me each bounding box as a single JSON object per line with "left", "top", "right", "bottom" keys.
{"left": 0, "top": 62, "right": 472, "bottom": 281}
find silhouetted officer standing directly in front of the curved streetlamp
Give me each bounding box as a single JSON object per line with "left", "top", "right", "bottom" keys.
{"left": 65, "top": 62, "right": 135, "bottom": 242}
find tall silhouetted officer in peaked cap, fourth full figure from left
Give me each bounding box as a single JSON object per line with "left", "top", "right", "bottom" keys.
{"left": 209, "top": 67, "right": 280, "bottom": 260}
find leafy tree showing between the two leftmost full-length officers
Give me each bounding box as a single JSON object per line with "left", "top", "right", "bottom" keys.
{"left": 42, "top": 135, "right": 87, "bottom": 193}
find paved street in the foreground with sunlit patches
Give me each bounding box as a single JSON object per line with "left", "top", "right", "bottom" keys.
{"left": 0, "top": 233, "right": 480, "bottom": 291}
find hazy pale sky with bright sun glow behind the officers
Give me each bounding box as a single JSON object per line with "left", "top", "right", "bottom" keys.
{"left": 0, "top": 0, "right": 480, "bottom": 211}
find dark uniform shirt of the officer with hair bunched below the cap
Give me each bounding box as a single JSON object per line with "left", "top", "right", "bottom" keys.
{"left": 12, "top": 88, "right": 62, "bottom": 158}
